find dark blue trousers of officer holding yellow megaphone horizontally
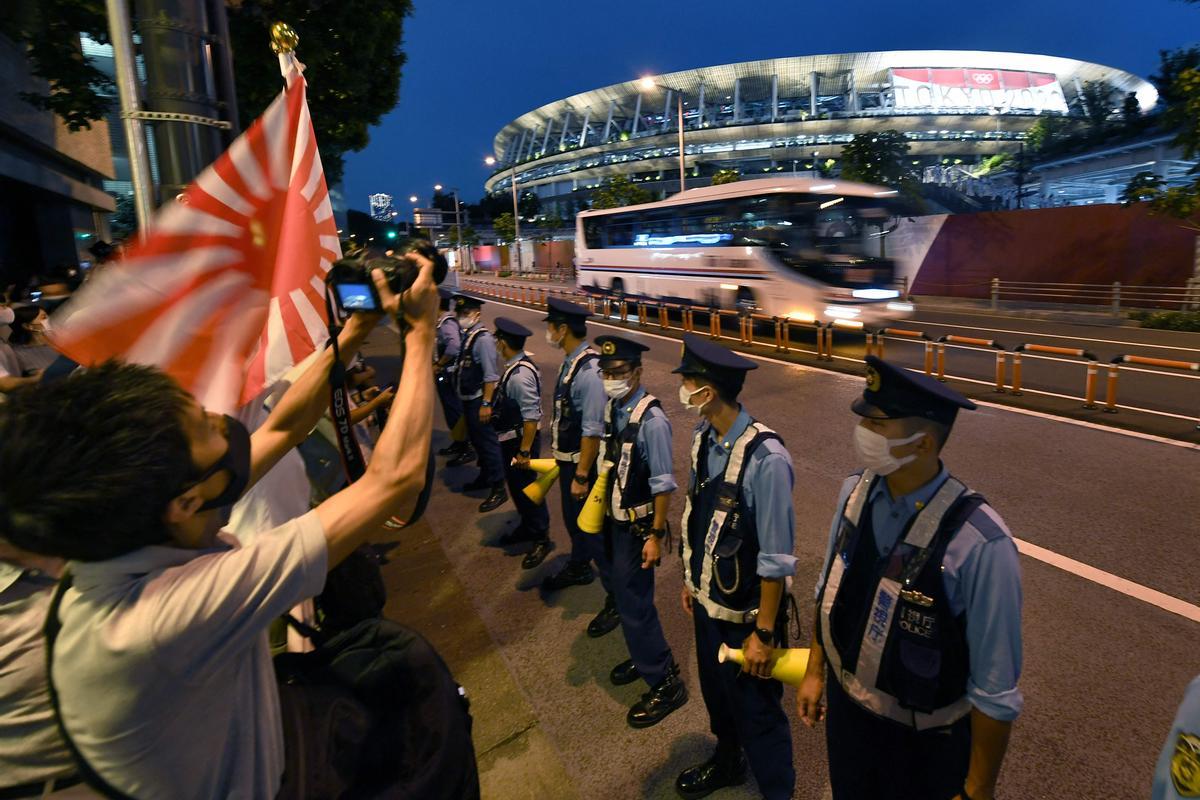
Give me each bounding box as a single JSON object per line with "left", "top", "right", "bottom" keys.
{"left": 692, "top": 603, "right": 796, "bottom": 800}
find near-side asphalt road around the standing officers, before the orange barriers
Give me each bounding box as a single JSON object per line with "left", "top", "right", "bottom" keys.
{"left": 381, "top": 302, "right": 1200, "bottom": 800}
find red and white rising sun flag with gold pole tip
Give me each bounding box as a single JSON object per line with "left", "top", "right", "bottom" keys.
{"left": 53, "top": 56, "right": 341, "bottom": 411}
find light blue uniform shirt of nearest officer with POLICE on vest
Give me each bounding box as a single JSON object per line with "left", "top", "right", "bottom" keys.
{"left": 817, "top": 467, "right": 1025, "bottom": 722}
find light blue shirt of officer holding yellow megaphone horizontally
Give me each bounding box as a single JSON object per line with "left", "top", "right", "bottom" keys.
{"left": 691, "top": 409, "right": 796, "bottom": 578}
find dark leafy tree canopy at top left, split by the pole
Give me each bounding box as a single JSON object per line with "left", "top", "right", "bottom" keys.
{"left": 0, "top": 0, "right": 413, "bottom": 185}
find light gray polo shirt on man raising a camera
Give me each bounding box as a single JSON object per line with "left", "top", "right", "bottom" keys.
{"left": 53, "top": 511, "right": 328, "bottom": 800}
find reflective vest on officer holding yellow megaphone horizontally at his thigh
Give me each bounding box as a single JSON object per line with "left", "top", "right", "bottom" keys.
{"left": 680, "top": 421, "right": 782, "bottom": 627}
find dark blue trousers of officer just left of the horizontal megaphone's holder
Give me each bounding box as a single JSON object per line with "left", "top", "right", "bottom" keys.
{"left": 605, "top": 519, "right": 671, "bottom": 688}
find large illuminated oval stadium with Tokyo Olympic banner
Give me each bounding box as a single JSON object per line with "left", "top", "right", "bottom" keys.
{"left": 486, "top": 50, "right": 1158, "bottom": 216}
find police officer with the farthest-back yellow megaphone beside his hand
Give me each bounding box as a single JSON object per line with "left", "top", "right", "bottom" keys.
{"left": 492, "top": 317, "right": 554, "bottom": 570}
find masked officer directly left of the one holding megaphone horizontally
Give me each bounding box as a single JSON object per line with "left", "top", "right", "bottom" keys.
{"left": 595, "top": 336, "right": 688, "bottom": 728}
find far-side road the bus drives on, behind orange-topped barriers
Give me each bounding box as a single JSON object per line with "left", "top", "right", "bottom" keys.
{"left": 453, "top": 276, "right": 1200, "bottom": 443}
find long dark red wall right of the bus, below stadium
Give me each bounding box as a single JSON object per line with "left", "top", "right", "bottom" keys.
{"left": 912, "top": 205, "right": 1196, "bottom": 297}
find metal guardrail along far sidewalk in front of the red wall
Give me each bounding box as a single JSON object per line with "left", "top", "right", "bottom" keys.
{"left": 991, "top": 278, "right": 1200, "bottom": 317}
